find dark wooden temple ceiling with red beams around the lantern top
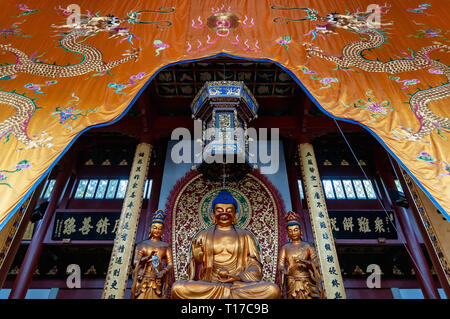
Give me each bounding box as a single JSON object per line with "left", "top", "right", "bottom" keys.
{"left": 90, "top": 58, "right": 363, "bottom": 140}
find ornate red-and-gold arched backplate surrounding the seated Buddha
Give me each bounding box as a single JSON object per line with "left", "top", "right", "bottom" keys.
{"left": 172, "top": 174, "right": 278, "bottom": 282}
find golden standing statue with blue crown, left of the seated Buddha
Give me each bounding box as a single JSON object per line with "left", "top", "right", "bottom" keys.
{"left": 131, "top": 210, "right": 173, "bottom": 299}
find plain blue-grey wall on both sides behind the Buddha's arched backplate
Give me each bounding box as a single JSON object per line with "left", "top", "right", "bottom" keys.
{"left": 158, "top": 141, "right": 292, "bottom": 211}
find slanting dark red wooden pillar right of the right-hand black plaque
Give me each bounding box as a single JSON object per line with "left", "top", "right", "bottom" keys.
{"left": 377, "top": 155, "right": 440, "bottom": 299}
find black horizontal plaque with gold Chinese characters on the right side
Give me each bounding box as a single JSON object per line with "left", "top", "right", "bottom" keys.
{"left": 328, "top": 211, "right": 398, "bottom": 239}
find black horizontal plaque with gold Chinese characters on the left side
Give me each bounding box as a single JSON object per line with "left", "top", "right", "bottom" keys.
{"left": 52, "top": 212, "right": 120, "bottom": 240}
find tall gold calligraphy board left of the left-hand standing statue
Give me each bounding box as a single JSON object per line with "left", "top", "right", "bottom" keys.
{"left": 102, "top": 143, "right": 152, "bottom": 299}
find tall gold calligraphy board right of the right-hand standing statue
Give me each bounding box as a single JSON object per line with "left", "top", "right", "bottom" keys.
{"left": 298, "top": 143, "right": 346, "bottom": 299}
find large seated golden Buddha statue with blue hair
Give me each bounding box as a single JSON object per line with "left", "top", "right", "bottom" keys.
{"left": 172, "top": 190, "right": 280, "bottom": 299}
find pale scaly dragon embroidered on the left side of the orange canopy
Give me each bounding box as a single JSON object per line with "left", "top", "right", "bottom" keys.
{"left": 0, "top": 16, "right": 139, "bottom": 150}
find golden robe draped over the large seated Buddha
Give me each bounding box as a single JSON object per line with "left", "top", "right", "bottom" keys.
{"left": 172, "top": 227, "right": 280, "bottom": 299}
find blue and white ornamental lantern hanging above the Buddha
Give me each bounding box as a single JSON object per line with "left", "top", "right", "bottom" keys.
{"left": 191, "top": 81, "right": 259, "bottom": 180}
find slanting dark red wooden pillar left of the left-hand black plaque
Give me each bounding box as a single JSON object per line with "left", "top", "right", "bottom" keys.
{"left": 9, "top": 156, "right": 74, "bottom": 299}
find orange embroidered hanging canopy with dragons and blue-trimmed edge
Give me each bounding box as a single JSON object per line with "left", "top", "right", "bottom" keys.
{"left": 0, "top": 0, "right": 450, "bottom": 229}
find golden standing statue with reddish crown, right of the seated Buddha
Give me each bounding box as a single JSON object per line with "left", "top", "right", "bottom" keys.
{"left": 278, "top": 211, "right": 323, "bottom": 299}
